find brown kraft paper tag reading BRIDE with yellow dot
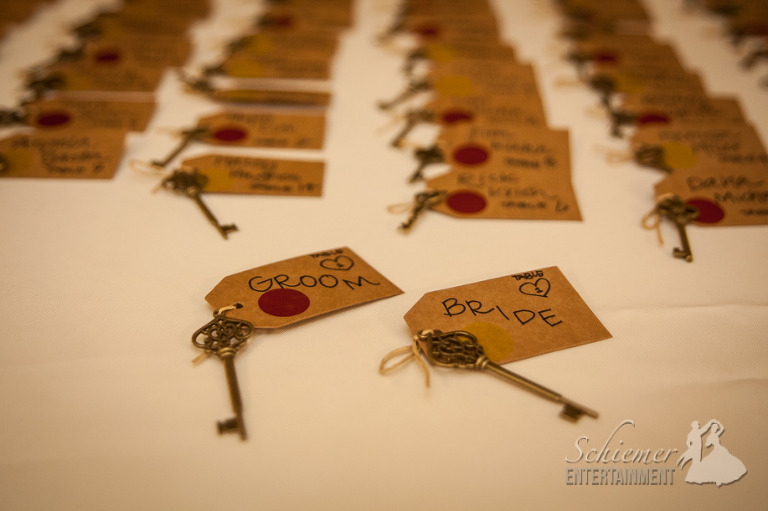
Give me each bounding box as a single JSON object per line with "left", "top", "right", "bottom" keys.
{"left": 405, "top": 266, "right": 611, "bottom": 364}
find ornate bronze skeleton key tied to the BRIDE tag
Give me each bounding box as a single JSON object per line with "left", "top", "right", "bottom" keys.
{"left": 416, "top": 330, "right": 598, "bottom": 422}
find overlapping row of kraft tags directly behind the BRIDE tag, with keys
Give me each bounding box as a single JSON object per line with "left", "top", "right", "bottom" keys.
{"left": 379, "top": 0, "right": 581, "bottom": 230}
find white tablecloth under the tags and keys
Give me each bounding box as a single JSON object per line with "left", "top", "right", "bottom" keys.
{"left": 0, "top": 0, "right": 768, "bottom": 511}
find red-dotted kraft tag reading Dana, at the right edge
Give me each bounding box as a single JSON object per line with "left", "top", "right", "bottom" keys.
{"left": 655, "top": 159, "right": 768, "bottom": 226}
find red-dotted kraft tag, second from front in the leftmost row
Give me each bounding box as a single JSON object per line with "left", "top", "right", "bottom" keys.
{"left": 24, "top": 97, "right": 155, "bottom": 131}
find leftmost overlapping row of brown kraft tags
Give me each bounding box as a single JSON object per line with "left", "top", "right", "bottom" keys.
{"left": 0, "top": 0, "right": 209, "bottom": 179}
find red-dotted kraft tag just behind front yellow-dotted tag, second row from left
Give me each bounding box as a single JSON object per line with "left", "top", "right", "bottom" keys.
{"left": 197, "top": 110, "right": 325, "bottom": 149}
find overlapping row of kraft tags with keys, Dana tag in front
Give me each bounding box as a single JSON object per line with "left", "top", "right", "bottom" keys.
{"left": 559, "top": 0, "right": 768, "bottom": 261}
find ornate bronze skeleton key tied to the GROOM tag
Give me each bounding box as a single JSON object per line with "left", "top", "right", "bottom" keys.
{"left": 192, "top": 310, "right": 253, "bottom": 440}
